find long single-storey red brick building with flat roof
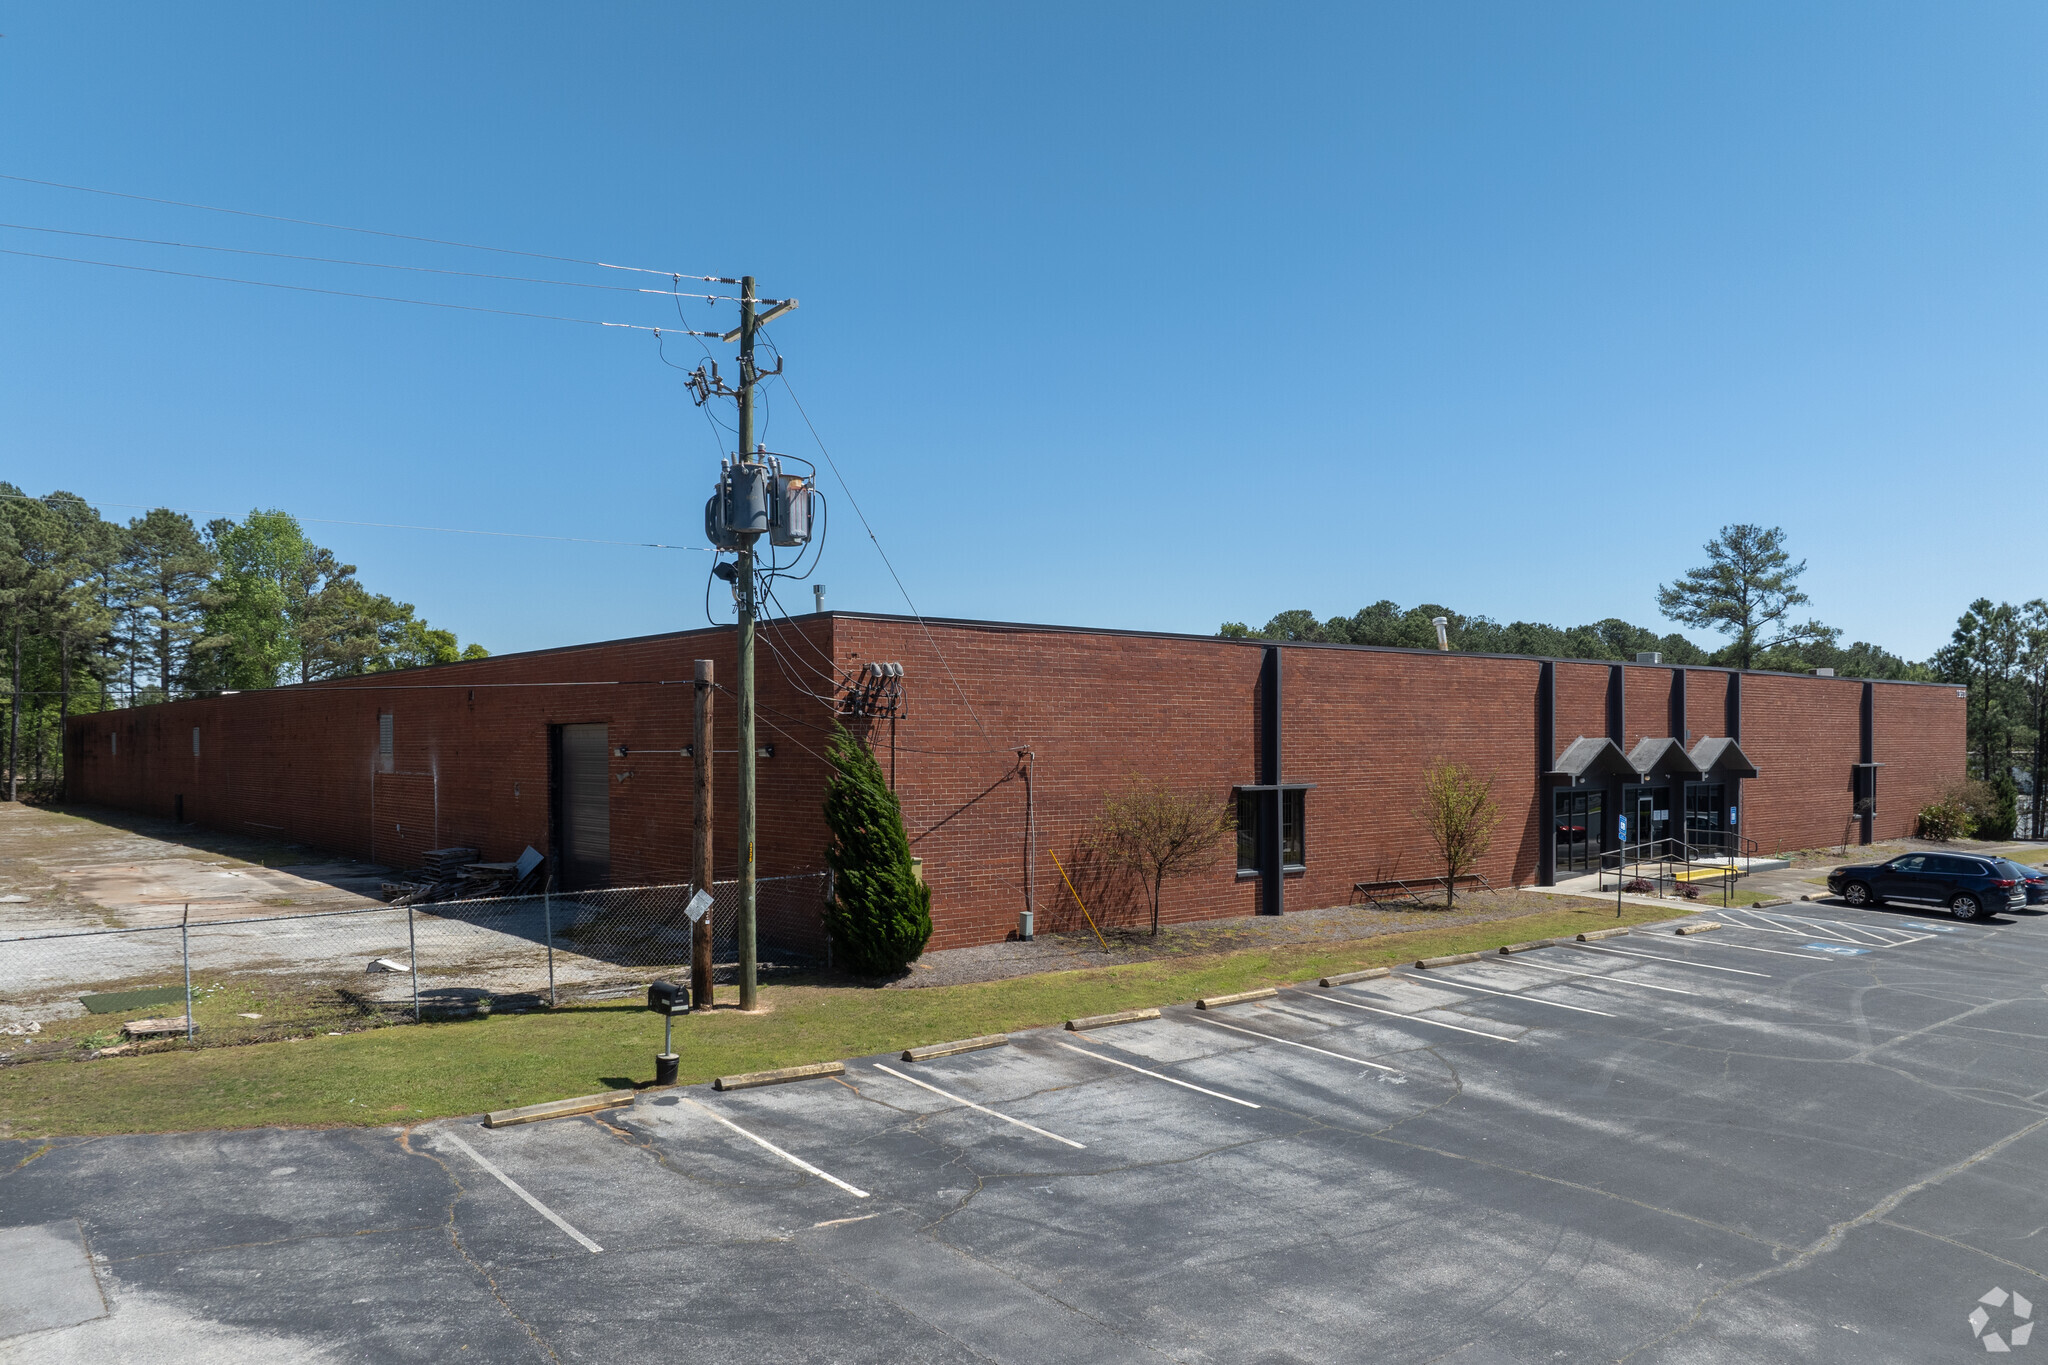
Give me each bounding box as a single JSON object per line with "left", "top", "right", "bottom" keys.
{"left": 66, "top": 612, "right": 1966, "bottom": 950}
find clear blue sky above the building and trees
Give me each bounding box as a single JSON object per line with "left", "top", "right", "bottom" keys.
{"left": 0, "top": 2, "right": 2048, "bottom": 657}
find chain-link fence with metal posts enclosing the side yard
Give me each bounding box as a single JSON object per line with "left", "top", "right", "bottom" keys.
{"left": 0, "top": 872, "right": 829, "bottom": 1064}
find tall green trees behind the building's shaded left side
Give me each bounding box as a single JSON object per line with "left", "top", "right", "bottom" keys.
{"left": 0, "top": 481, "right": 487, "bottom": 796}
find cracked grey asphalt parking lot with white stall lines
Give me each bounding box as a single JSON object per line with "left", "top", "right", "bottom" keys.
{"left": 0, "top": 905, "right": 2048, "bottom": 1365}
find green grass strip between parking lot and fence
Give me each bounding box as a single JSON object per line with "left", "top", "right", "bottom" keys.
{"left": 0, "top": 900, "right": 1681, "bottom": 1138}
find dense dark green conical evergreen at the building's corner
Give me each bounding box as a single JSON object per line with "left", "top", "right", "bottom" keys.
{"left": 825, "top": 729, "right": 932, "bottom": 976}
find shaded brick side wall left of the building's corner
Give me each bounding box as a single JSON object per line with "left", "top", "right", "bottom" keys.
{"left": 68, "top": 618, "right": 829, "bottom": 945}
